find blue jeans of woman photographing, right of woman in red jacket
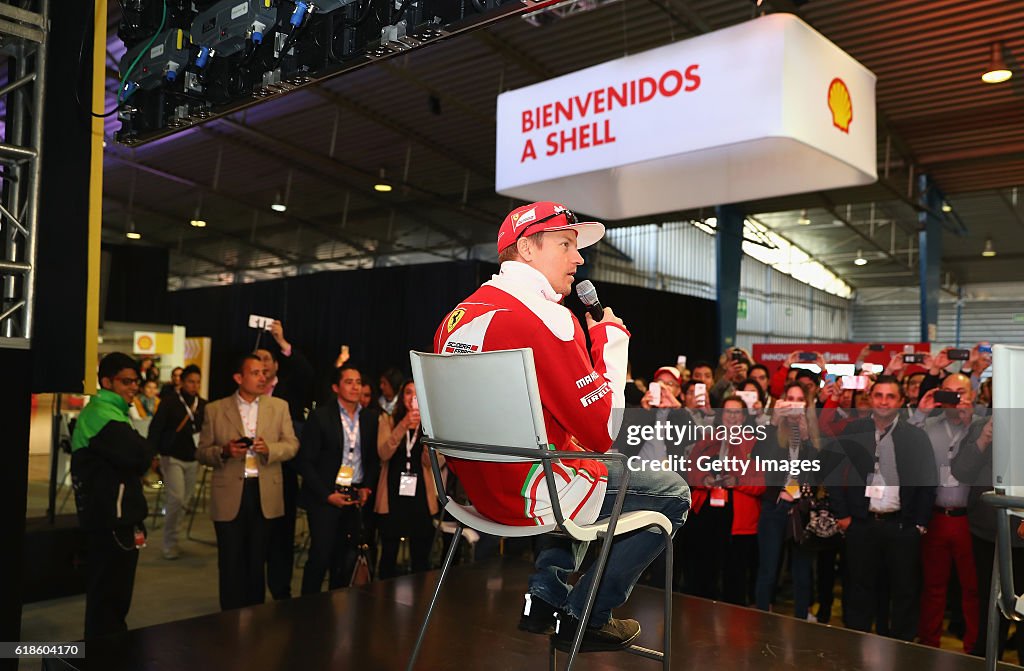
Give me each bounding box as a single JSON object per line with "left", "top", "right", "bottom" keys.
{"left": 755, "top": 499, "right": 813, "bottom": 620}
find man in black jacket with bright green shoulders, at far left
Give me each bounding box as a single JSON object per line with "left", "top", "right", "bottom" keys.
{"left": 71, "top": 352, "right": 153, "bottom": 639}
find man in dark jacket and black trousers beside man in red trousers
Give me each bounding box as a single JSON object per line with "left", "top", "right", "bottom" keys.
{"left": 831, "top": 375, "right": 937, "bottom": 640}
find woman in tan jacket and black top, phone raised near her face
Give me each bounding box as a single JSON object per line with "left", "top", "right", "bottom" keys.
{"left": 374, "top": 381, "right": 442, "bottom": 579}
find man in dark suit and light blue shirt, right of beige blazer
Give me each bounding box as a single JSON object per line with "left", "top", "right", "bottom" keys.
{"left": 295, "top": 365, "right": 386, "bottom": 594}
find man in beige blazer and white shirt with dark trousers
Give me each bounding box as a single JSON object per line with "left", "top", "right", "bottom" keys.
{"left": 196, "top": 354, "right": 299, "bottom": 611}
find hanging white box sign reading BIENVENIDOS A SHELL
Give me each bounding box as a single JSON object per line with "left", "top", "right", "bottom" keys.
{"left": 496, "top": 14, "right": 878, "bottom": 219}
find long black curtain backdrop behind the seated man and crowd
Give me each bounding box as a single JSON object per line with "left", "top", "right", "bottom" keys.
{"left": 163, "top": 261, "right": 715, "bottom": 399}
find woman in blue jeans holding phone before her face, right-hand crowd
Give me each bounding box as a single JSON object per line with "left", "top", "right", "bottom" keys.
{"left": 756, "top": 381, "right": 821, "bottom": 620}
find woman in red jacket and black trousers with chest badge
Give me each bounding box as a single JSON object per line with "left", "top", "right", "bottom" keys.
{"left": 688, "top": 396, "right": 765, "bottom": 605}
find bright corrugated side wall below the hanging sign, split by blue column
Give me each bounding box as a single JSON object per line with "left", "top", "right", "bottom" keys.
{"left": 588, "top": 222, "right": 850, "bottom": 348}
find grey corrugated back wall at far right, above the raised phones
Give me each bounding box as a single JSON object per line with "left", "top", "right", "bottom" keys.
{"left": 852, "top": 300, "right": 1024, "bottom": 346}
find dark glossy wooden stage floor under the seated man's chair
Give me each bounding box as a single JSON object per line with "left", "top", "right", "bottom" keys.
{"left": 47, "top": 558, "right": 1018, "bottom": 671}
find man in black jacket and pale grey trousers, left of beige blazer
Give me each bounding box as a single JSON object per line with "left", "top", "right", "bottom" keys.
{"left": 146, "top": 366, "right": 206, "bottom": 559}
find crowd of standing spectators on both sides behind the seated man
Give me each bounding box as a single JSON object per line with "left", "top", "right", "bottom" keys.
{"left": 75, "top": 336, "right": 1024, "bottom": 654}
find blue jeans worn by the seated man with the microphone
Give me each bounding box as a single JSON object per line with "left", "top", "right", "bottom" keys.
{"left": 529, "top": 462, "right": 690, "bottom": 627}
